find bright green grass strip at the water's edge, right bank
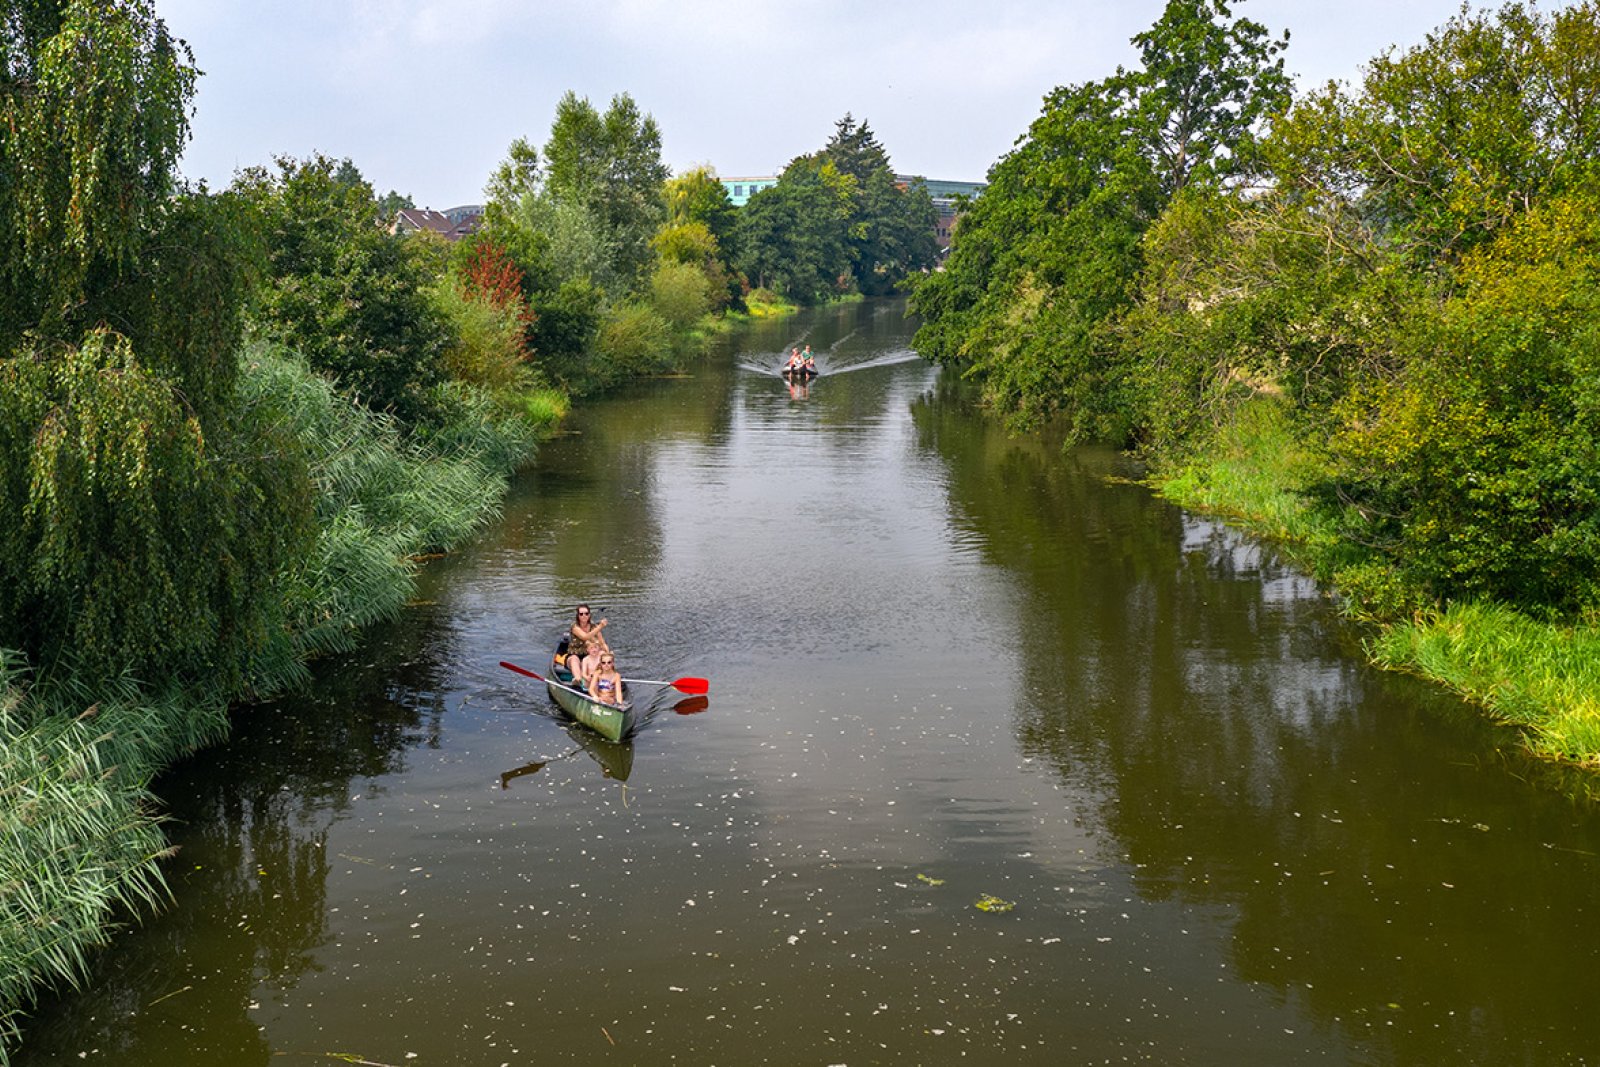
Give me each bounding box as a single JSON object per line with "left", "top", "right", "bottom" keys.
{"left": 1154, "top": 400, "right": 1600, "bottom": 768}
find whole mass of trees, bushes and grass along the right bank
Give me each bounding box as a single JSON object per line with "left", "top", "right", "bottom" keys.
{"left": 915, "top": 0, "right": 1600, "bottom": 761}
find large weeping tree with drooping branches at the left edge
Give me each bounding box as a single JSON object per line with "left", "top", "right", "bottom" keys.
{"left": 0, "top": 0, "right": 309, "bottom": 688}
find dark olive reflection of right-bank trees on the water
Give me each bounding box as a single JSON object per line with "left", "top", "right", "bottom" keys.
{"left": 917, "top": 371, "right": 1600, "bottom": 1064}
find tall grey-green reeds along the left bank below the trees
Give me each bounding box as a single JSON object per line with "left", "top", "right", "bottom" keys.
{"left": 0, "top": 346, "right": 566, "bottom": 1067}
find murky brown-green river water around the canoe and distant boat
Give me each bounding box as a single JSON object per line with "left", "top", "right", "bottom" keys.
{"left": 14, "top": 302, "right": 1600, "bottom": 1067}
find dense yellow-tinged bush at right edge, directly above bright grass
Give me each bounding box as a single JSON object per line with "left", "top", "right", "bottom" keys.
{"left": 1323, "top": 185, "right": 1600, "bottom": 617}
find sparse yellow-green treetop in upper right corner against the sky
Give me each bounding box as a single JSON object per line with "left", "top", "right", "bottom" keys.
{"left": 1269, "top": 0, "right": 1600, "bottom": 264}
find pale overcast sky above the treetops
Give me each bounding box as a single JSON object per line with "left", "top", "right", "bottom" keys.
{"left": 157, "top": 0, "right": 1565, "bottom": 208}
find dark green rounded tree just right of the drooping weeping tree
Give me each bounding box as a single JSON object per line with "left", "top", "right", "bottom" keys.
{"left": 235, "top": 157, "right": 450, "bottom": 422}
